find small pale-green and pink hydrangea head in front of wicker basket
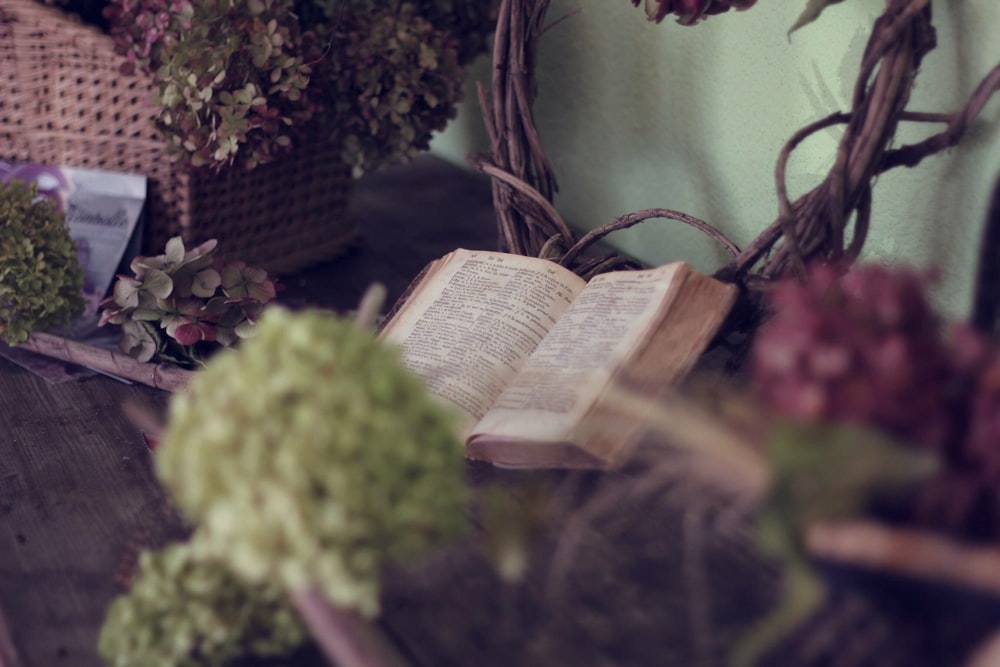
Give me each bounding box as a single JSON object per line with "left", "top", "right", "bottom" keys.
{"left": 100, "top": 236, "right": 277, "bottom": 368}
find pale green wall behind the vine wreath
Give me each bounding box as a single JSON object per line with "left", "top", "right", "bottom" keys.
{"left": 434, "top": 0, "right": 1000, "bottom": 315}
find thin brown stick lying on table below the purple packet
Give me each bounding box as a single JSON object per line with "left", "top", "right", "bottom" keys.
{"left": 19, "top": 333, "right": 194, "bottom": 391}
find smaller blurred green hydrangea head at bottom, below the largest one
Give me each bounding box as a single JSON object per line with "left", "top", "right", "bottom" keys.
{"left": 98, "top": 536, "right": 306, "bottom": 667}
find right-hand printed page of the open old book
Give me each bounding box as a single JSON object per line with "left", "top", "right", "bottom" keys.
{"left": 473, "top": 263, "right": 683, "bottom": 442}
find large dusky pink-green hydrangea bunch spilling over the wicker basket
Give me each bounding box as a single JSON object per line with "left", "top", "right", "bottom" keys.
{"left": 95, "top": 0, "right": 494, "bottom": 170}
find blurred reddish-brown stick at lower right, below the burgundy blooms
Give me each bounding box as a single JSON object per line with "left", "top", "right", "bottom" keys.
{"left": 805, "top": 521, "right": 1000, "bottom": 597}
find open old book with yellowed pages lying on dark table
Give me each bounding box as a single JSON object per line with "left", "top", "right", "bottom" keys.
{"left": 381, "top": 249, "right": 737, "bottom": 468}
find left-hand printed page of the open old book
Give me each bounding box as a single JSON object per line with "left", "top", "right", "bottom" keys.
{"left": 382, "top": 250, "right": 585, "bottom": 433}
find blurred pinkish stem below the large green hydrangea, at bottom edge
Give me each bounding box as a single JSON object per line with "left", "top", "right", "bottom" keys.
{"left": 292, "top": 588, "right": 409, "bottom": 667}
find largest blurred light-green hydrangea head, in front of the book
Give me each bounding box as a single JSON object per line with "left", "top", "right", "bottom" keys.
{"left": 157, "top": 308, "right": 465, "bottom": 616}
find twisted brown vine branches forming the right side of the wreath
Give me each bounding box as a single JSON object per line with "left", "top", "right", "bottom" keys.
{"left": 717, "top": 0, "right": 1000, "bottom": 285}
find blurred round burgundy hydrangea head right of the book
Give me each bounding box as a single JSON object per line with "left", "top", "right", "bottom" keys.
{"left": 752, "top": 265, "right": 953, "bottom": 448}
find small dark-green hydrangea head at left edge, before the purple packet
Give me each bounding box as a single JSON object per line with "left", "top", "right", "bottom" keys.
{"left": 0, "top": 181, "right": 84, "bottom": 345}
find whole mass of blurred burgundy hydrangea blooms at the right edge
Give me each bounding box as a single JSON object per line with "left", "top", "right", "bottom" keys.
{"left": 751, "top": 265, "right": 1000, "bottom": 537}
